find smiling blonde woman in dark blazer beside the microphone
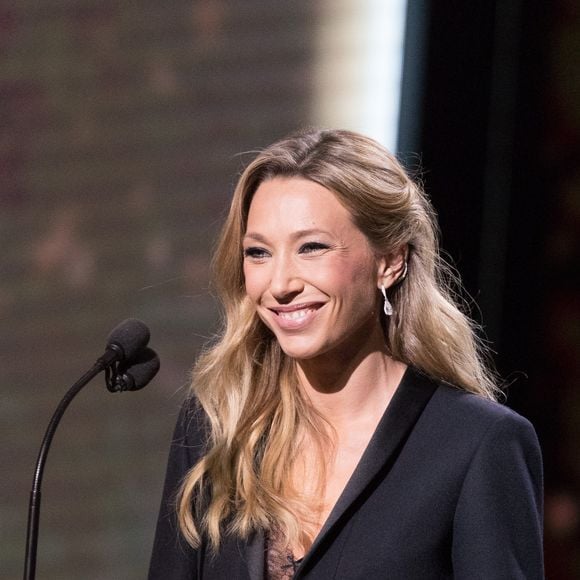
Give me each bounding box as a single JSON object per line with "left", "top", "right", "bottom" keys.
{"left": 150, "top": 131, "right": 543, "bottom": 580}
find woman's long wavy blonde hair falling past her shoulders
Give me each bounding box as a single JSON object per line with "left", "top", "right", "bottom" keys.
{"left": 177, "top": 130, "right": 498, "bottom": 549}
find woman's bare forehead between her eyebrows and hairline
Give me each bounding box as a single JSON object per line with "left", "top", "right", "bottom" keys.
{"left": 247, "top": 177, "right": 356, "bottom": 230}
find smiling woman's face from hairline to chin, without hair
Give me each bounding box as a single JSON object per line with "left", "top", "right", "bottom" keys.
{"left": 243, "top": 177, "right": 384, "bottom": 359}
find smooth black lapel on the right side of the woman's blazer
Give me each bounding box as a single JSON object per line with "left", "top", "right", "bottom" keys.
{"left": 295, "top": 367, "right": 438, "bottom": 578}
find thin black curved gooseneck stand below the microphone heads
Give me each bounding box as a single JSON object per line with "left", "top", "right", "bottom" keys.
{"left": 24, "top": 354, "right": 119, "bottom": 580}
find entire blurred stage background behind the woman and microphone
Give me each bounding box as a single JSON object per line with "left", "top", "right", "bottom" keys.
{"left": 0, "top": 0, "right": 580, "bottom": 580}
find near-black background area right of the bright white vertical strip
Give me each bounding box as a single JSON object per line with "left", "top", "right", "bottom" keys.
{"left": 399, "top": 0, "right": 580, "bottom": 579}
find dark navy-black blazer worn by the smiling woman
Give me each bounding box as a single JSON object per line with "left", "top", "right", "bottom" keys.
{"left": 149, "top": 368, "right": 544, "bottom": 580}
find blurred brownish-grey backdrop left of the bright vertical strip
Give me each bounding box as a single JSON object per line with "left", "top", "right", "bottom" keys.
{"left": 0, "top": 0, "right": 315, "bottom": 580}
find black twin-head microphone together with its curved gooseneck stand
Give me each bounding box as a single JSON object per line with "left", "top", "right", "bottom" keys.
{"left": 24, "top": 318, "right": 159, "bottom": 580}
